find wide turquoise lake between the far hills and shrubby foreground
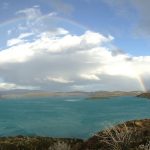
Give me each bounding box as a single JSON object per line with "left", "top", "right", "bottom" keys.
{"left": 0, "top": 97, "right": 150, "bottom": 138}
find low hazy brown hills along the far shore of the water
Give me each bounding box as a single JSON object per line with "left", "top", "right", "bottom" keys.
{"left": 0, "top": 89, "right": 142, "bottom": 99}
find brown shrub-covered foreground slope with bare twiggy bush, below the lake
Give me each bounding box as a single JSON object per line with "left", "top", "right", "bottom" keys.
{"left": 0, "top": 119, "right": 150, "bottom": 150}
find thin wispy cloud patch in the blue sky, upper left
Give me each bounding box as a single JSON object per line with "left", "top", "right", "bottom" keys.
{"left": 15, "top": 5, "right": 57, "bottom": 33}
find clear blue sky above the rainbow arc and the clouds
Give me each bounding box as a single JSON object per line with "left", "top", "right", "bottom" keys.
{"left": 0, "top": 0, "right": 150, "bottom": 55}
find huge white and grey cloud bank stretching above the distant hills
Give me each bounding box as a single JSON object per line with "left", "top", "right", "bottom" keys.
{"left": 0, "top": 28, "right": 150, "bottom": 91}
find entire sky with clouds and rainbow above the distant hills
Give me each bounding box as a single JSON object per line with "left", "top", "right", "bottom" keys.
{"left": 0, "top": 0, "right": 150, "bottom": 91}
